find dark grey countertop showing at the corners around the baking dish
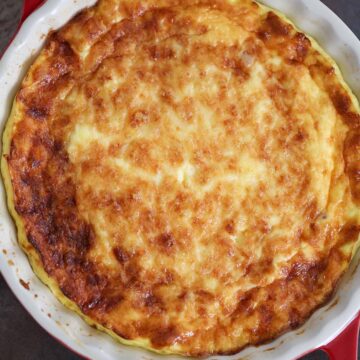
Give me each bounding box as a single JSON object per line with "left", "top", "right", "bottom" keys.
{"left": 0, "top": 0, "right": 360, "bottom": 360}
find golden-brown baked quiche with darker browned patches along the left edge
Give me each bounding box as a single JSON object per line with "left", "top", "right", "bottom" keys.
{"left": 2, "top": 0, "right": 360, "bottom": 356}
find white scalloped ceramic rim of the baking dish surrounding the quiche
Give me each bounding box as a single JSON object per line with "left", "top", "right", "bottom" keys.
{"left": 0, "top": 0, "right": 360, "bottom": 360}
